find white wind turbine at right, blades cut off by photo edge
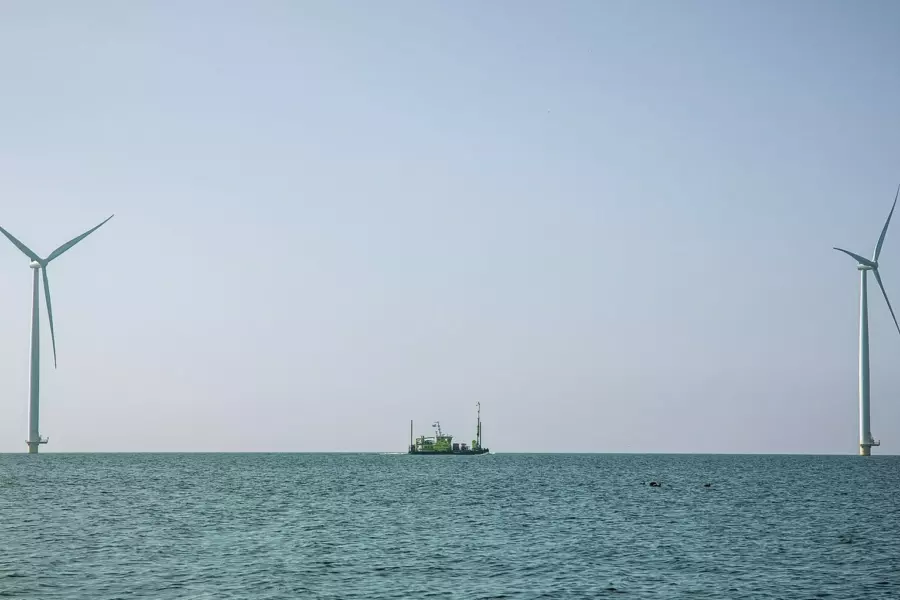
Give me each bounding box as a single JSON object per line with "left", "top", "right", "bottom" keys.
{"left": 835, "top": 187, "right": 900, "bottom": 456}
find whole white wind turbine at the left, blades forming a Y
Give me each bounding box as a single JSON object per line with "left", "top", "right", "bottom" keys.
{"left": 0, "top": 215, "right": 114, "bottom": 454}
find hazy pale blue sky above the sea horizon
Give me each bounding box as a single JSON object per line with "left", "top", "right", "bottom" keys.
{"left": 0, "top": 0, "right": 900, "bottom": 454}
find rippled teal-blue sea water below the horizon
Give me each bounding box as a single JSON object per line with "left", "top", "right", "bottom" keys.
{"left": 0, "top": 454, "right": 900, "bottom": 600}
